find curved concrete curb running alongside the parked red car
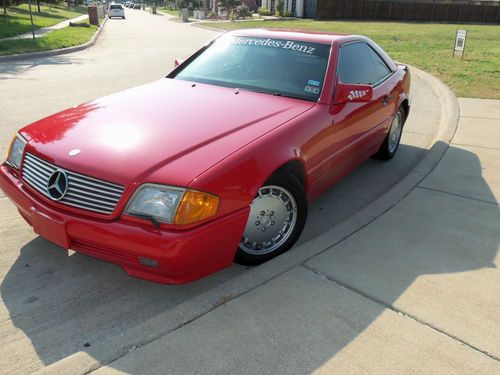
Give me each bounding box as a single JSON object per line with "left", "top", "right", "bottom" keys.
{"left": 33, "top": 68, "right": 459, "bottom": 374}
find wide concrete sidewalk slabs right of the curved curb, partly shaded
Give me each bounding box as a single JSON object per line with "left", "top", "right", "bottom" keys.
{"left": 97, "top": 99, "right": 500, "bottom": 374}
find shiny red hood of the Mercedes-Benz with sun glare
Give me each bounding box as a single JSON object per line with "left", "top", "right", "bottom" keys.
{"left": 20, "top": 78, "right": 314, "bottom": 185}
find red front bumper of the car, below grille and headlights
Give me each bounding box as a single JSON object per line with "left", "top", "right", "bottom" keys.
{"left": 0, "top": 165, "right": 249, "bottom": 284}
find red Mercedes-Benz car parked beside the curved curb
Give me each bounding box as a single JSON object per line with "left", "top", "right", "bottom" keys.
{"left": 0, "top": 30, "right": 410, "bottom": 283}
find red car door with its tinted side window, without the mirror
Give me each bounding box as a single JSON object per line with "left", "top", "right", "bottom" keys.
{"left": 311, "top": 40, "right": 397, "bottom": 197}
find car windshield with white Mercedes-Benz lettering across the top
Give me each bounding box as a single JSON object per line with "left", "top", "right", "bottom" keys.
{"left": 175, "top": 35, "right": 330, "bottom": 101}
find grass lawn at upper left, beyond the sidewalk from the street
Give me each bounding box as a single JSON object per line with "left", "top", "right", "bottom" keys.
{"left": 0, "top": 4, "right": 87, "bottom": 38}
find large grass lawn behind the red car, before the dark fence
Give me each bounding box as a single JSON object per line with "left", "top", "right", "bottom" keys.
{"left": 203, "top": 20, "right": 500, "bottom": 99}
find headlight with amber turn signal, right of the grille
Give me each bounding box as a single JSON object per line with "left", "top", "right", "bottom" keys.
{"left": 126, "top": 184, "right": 219, "bottom": 225}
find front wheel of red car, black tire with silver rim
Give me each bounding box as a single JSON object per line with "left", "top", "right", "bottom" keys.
{"left": 234, "top": 172, "right": 307, "bottom": 266}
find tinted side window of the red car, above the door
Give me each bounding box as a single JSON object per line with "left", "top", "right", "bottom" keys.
{"left": 337, "top": 42, "right": 392, "bottom": 85}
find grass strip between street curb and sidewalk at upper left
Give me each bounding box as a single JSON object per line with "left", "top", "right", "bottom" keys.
{"left": 0, "top": 26, "right": 97, "bottom": 56}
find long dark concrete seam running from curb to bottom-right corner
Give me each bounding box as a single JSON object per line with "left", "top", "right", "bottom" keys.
{"left": 301, "top": 264, "right": 500, "bottom": 362}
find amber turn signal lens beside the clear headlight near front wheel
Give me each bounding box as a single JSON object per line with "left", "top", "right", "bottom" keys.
{"left": 173, "top": 190, "right": 219, "bottom": 225}
